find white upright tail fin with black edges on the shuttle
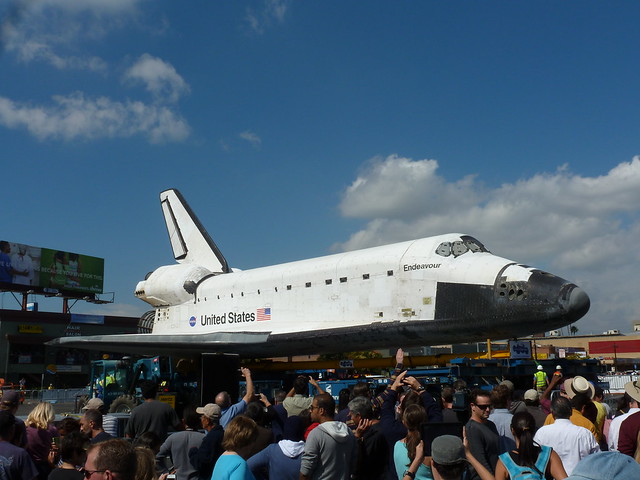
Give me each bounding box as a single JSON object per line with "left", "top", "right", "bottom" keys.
{"left": 160, "top": 189, "right": 231, "bottom": 273}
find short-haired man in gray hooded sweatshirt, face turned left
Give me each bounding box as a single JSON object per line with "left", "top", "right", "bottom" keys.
{"left": 300, "top": 393, "right": 357, "bottom": 480}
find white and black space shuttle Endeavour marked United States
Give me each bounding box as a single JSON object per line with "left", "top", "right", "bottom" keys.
{"left": 53, "top": 189, "right": 590, "bottom": 357}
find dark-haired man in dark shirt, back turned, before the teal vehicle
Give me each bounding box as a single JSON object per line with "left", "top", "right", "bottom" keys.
{"left": 125, "top": 380, "right": 183, "bottom": 441}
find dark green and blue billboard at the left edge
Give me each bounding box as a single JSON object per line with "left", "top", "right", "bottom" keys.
{"left": 0, "top": 240, "right": 104, "bottom": 297}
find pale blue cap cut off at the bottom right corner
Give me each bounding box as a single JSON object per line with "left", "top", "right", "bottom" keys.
{"left": 567, "top": 452, "right": 640, "bottom": 480}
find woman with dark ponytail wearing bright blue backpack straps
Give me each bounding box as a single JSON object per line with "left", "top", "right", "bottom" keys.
{"left": 495, "top": 412, "right": 567, "bottom": 480}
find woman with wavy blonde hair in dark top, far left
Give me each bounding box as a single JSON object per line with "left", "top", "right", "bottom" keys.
{"left": 24, "top": 402, "right": 59, "bottom": 480}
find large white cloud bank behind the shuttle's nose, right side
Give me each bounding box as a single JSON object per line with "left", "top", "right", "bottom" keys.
{"left": 334, "top": 155, "right": 640, "bottom": 331}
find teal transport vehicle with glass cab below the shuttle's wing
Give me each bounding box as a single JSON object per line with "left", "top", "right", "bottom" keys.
{"left": 77, "top": 356, "right": 199, "bottom": 413}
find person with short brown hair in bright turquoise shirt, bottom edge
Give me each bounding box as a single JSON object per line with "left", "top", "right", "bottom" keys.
{"left": 211, "top": 415, "right": 258, "bottom": 480}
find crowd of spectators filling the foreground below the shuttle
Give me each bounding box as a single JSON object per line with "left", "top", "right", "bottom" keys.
{"left": 0, "top": 350, "right": 640, "bottom": 480}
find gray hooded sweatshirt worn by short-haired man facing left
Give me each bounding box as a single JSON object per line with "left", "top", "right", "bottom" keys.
{"left": 300, "top": 421, "right": 357, "bottom": 480}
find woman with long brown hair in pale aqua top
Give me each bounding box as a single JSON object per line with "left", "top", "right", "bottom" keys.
{"left": 393, "top": 404, "right": 433, "bottom": 480}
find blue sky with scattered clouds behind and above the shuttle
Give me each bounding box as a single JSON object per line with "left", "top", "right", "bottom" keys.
{"left": 0, "top": 0, "right": 640, "bottom": 338}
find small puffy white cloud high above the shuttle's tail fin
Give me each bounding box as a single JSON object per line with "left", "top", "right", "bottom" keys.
{"left": 124, "top": 53, "right": 190, "bottom": 102}
